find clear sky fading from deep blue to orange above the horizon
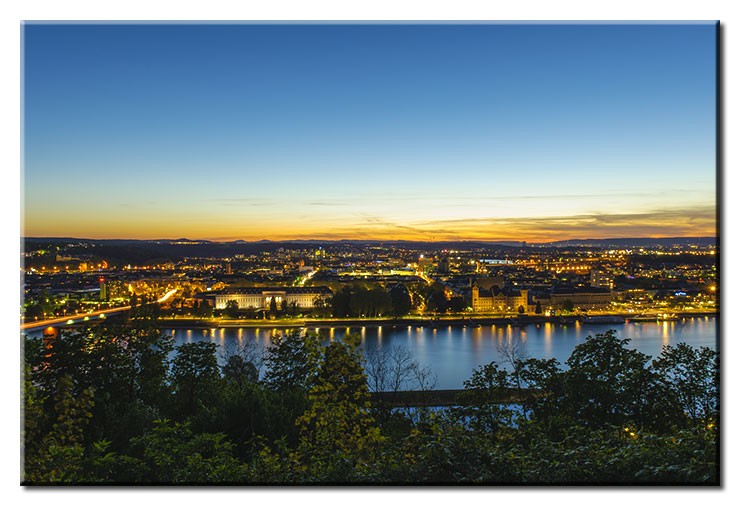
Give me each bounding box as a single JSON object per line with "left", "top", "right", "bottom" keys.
{"left": 22, "top": 22, "right": 717, "bottom": 242}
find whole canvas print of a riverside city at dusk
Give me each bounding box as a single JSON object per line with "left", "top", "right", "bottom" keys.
{"left": 20, "top": 21, "right": 721, "bottom": 487}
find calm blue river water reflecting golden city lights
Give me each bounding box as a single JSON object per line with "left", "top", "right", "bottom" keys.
{"left": 165, "top": 316, "right": 719, "bottom": 389}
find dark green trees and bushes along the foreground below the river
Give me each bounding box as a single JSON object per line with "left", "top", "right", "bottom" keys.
{"left": 22, "top": 321, "right": 719, "bottom": 485}
